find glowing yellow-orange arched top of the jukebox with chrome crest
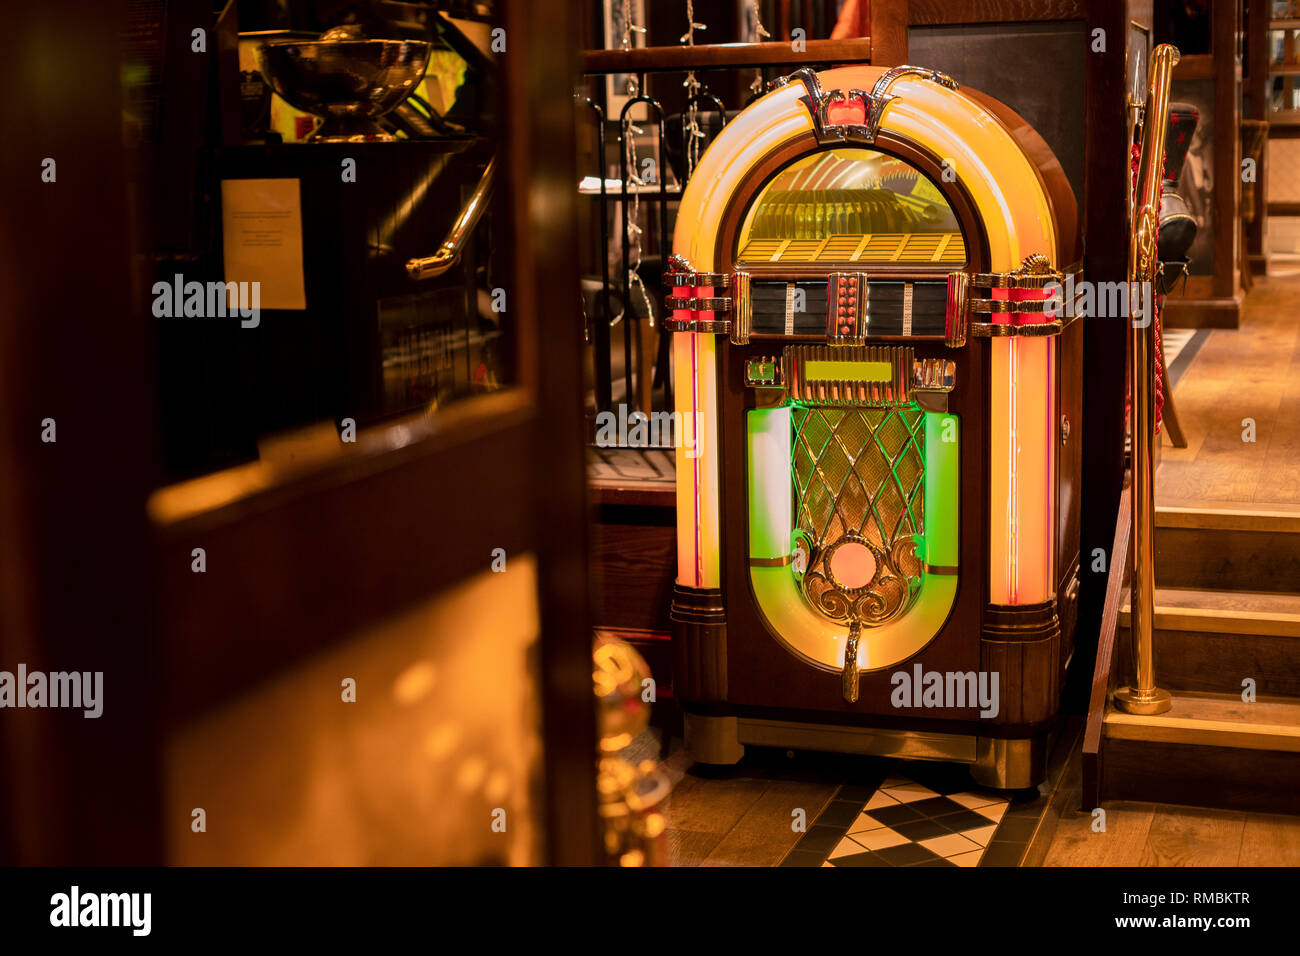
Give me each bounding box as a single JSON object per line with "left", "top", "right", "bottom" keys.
{"left": 673, "top": 66, "right": 1079, "bottom": 282}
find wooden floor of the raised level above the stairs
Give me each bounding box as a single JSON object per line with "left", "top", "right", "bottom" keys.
{"left": 1156, "top": 276, "right": 1300, "bottom": 510}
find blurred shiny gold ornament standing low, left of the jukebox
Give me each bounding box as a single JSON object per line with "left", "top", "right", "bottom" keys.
{"left": 592, "top": 635, "right": 672, "bottom": 866}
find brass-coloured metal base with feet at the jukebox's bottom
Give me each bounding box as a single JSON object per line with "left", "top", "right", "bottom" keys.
{"left": 684, "top": 711, "right": 1050, "bottom": 790}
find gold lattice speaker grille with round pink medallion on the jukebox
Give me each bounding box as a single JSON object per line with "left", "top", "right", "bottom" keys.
{"left": 790, "top": 403, "right": 926, "bottom": 627}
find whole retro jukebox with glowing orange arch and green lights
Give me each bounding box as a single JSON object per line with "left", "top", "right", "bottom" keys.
{"left": 666, "top": 66, "right": 1082, "bottom": 787}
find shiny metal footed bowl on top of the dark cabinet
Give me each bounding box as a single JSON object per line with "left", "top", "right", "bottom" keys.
{"left": 260, "top": 39, "right": 429, "bottom": 143}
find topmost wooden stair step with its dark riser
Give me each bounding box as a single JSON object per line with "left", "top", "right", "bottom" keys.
{"left": 1156, "top": 503, "right": 1300, "bottom": 592}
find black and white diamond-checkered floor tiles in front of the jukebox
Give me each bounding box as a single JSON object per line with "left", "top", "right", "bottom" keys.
{"left": 823, "top": 777, "right": 1010, "bottom": 866}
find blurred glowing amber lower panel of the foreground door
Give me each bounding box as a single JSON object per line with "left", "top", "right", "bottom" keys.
{"left": 165, "top": 555, "right": 545, "bottom": 866}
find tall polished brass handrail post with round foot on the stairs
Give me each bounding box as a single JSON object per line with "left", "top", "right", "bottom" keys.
{"left": 1112, "top": 43, "right": 1178, "bottom": 714}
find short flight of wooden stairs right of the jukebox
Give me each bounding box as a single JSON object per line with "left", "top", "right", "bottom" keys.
{"left": 1083, "top": 492, "right": 1300, "bottom": 813}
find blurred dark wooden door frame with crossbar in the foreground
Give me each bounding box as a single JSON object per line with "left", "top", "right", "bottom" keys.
{"left": 0, "top": 0, "right": 601, "bottom": 865}
